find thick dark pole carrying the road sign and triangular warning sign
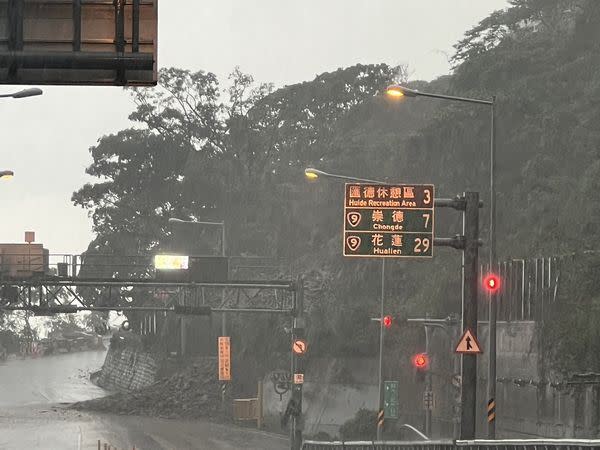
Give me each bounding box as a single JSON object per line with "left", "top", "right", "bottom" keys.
{"left": 460, "top": 192, "right": 479, "bottom": 440}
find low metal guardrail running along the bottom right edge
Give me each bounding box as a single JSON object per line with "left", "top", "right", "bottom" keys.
{"left": 302, "top": 439, "right": 600, "bottom": 450}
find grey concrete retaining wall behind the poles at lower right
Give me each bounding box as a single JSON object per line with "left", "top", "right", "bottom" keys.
{"left": 263, "top": 322, "right": 600, "bottom": 438}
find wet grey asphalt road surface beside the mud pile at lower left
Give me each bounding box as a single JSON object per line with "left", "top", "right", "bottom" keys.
{"left": 0, "top": 351, "right": 289, "bottom": 450}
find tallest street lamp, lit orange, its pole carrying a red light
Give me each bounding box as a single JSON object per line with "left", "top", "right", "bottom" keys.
{"left": 385, "top": 84, "right": 498, "bottom": 439}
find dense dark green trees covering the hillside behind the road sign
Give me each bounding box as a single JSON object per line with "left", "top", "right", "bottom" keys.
{"left": 73, "top": 0, "right": 600, "bottom": 370}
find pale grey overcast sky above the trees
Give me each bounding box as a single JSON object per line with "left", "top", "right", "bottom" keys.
{"left": 0, "top": 0, "right": 508, "bottom": 254}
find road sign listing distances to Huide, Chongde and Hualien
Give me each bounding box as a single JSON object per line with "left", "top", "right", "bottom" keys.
{"left": 344, "top": 183, "right": 434, "bottom": 258}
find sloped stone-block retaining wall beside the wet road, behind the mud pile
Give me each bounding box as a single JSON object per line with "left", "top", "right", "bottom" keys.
{"left": 97, "top": 346, "right": 158, "bottom": 392}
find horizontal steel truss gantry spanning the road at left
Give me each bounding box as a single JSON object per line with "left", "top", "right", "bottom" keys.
{"left": 0, "top": 277, "right": 296, "bottom": 315}
